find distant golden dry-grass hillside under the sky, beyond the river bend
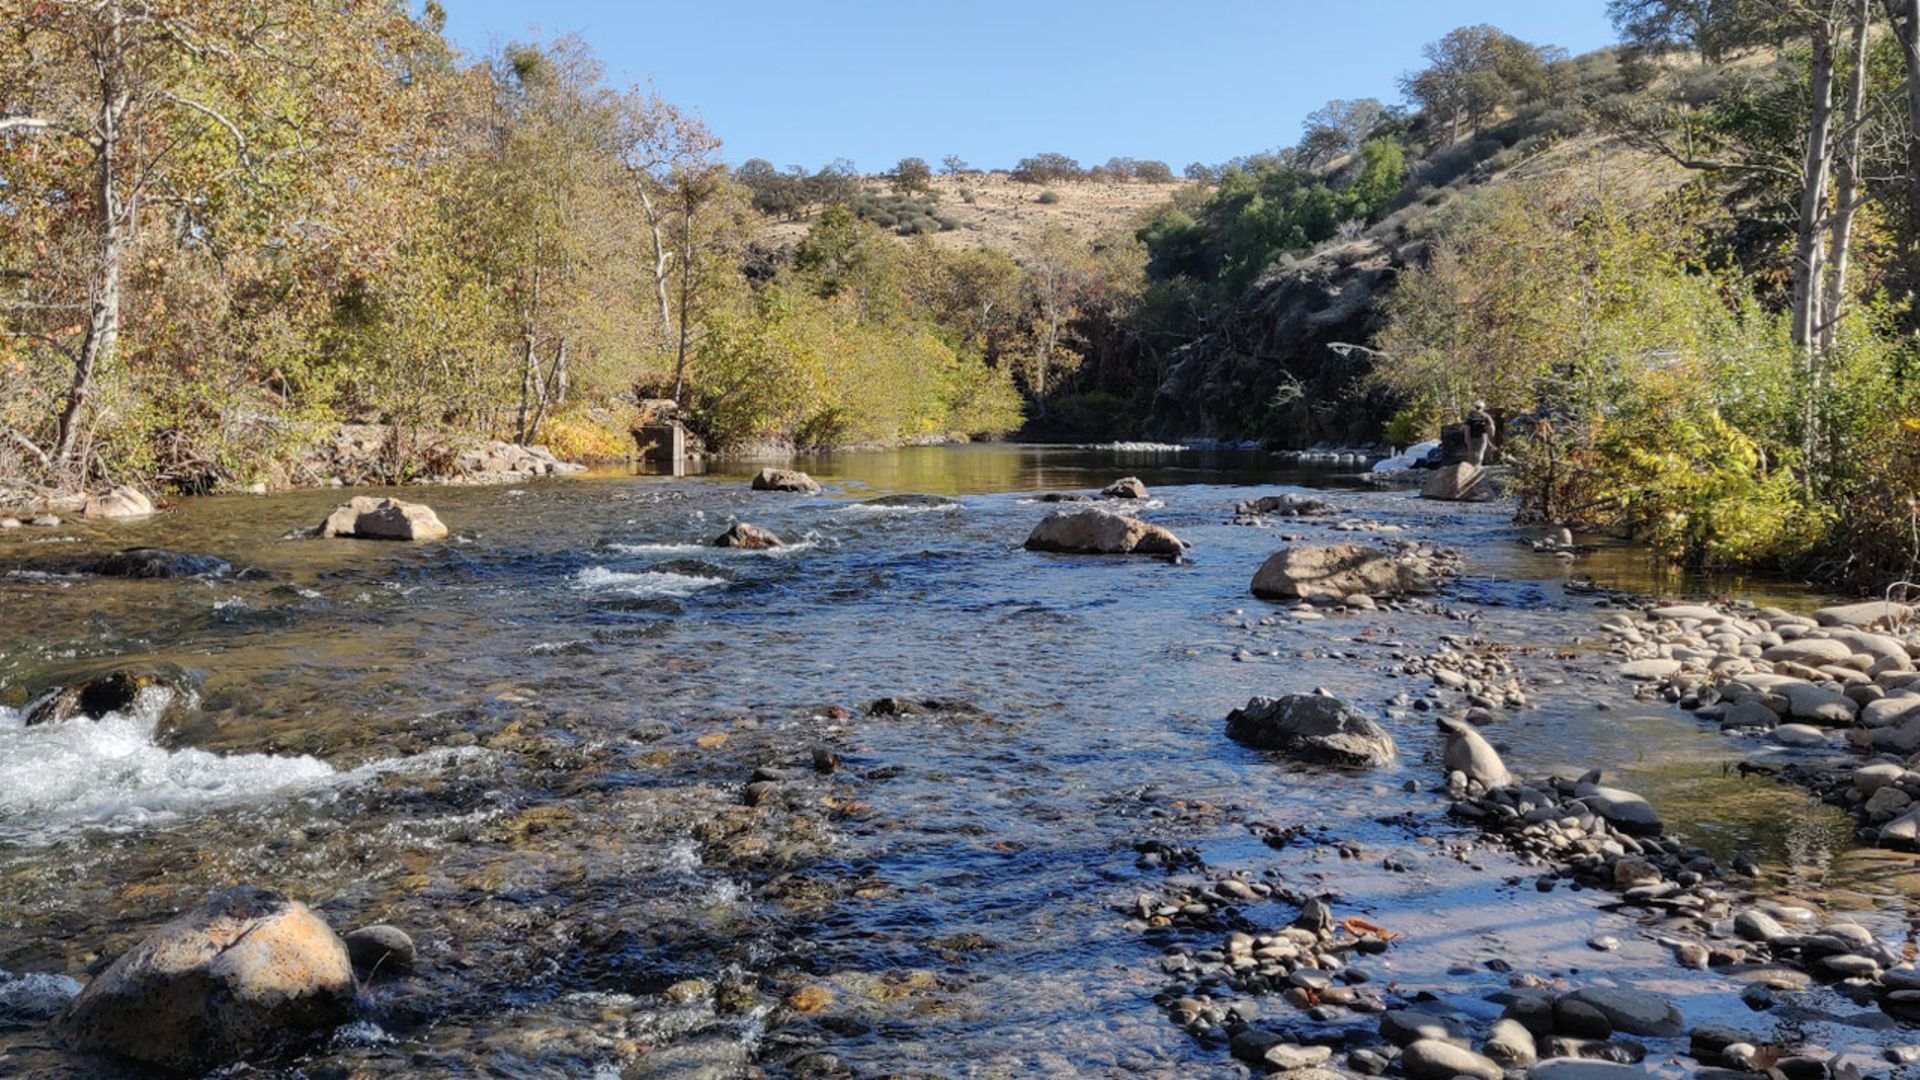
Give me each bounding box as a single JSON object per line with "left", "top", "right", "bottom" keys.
{"left": 760, "top": 173, "right": 1192, "bottom": 254}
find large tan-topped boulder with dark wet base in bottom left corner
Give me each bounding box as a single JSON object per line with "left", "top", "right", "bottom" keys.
{"left": 54, "top": 886, "right": 353, "bottom": 1072}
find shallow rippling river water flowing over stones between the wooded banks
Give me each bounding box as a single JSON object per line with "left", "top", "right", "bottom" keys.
{"left": 0, "top": 446, "right": 1916, "bottom": 1078}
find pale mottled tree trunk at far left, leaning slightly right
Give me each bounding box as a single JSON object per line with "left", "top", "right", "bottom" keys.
{"left": 54, "top": 4, "right": 134, "bottom": 480}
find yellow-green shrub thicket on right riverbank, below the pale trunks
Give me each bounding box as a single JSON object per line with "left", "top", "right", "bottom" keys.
{"left": 1373, "top": 180, "right": 1920, "bottom": 584}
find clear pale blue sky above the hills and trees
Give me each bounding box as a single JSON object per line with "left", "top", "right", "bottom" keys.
{"left": 444, "top": 0, "right": 1613, "bottom": 171}
